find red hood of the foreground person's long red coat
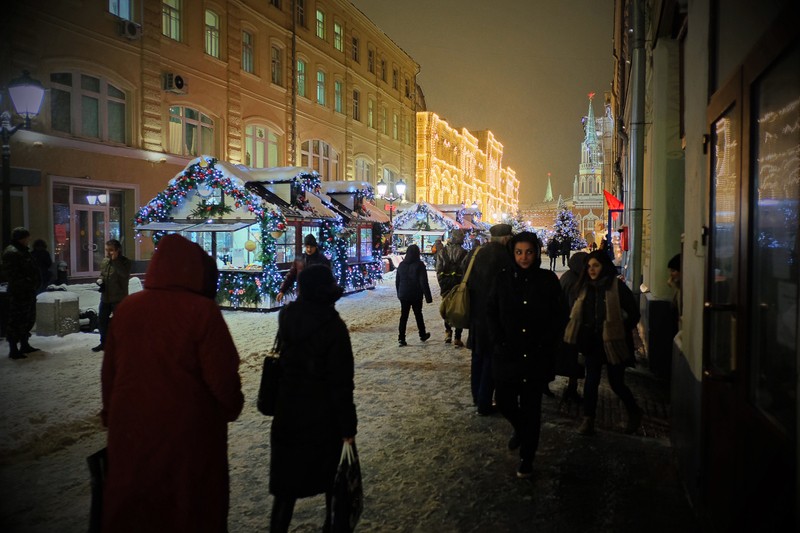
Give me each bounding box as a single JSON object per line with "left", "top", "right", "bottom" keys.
{"left": 144, "top": 234, "right": 219, "bottom": 298}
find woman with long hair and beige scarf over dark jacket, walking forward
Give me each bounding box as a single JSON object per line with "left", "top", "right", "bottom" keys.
{"left": 564, "top": 250, "right": 642, "bottom": 435}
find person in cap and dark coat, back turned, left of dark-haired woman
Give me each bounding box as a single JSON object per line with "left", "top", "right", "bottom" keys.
{"left": 466, "top": 224, "right": 514, "bottom": 416}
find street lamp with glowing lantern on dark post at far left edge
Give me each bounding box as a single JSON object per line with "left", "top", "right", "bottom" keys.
{"left": 0, "top": 70, "right": 44, "bottom": 247}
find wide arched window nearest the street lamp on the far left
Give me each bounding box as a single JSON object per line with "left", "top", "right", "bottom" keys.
{"left": 50, "top": 72, "right": 126, "bottom": 143}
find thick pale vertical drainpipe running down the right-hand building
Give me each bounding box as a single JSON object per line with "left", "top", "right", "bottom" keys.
{"left": 628, "top": 0, "right": 646, "bottom": 297}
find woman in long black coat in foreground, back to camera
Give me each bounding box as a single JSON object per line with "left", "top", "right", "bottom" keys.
{"left": 269, "top": 265, "right": 357, "bottom": 533}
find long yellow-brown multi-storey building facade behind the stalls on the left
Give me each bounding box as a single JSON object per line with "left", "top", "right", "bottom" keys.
{"left": 0, "top": 0, "right": 421, "bottom": 279}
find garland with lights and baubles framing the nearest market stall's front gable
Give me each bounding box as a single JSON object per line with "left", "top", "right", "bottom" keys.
{"left": 134, "top": 157, "right": 290, "bottom": 308}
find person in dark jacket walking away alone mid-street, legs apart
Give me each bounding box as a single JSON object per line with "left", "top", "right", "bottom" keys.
{"left": 394, "top": 244, "right": 433, "bottom": 347}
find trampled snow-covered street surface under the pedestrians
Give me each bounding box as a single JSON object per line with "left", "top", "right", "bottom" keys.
{"left": 0, "top": 272, "right": 694, "bottom": 533}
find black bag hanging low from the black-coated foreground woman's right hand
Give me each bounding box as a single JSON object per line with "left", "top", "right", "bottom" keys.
{"left": 331, "top": 442, "right": 364, "bottom": 533}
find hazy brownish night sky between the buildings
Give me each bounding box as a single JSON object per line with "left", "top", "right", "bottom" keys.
{"left": 352, "top": 0, "right": 614, "bottom": 205}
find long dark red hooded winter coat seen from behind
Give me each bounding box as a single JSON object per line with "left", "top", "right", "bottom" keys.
{"left": 102, "top": 235, "right": 244, "bottom": 532}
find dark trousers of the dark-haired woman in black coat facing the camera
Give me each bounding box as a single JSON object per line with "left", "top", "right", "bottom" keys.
{"left": 495, "top": 380, "right": 544, "bottom": 461}
